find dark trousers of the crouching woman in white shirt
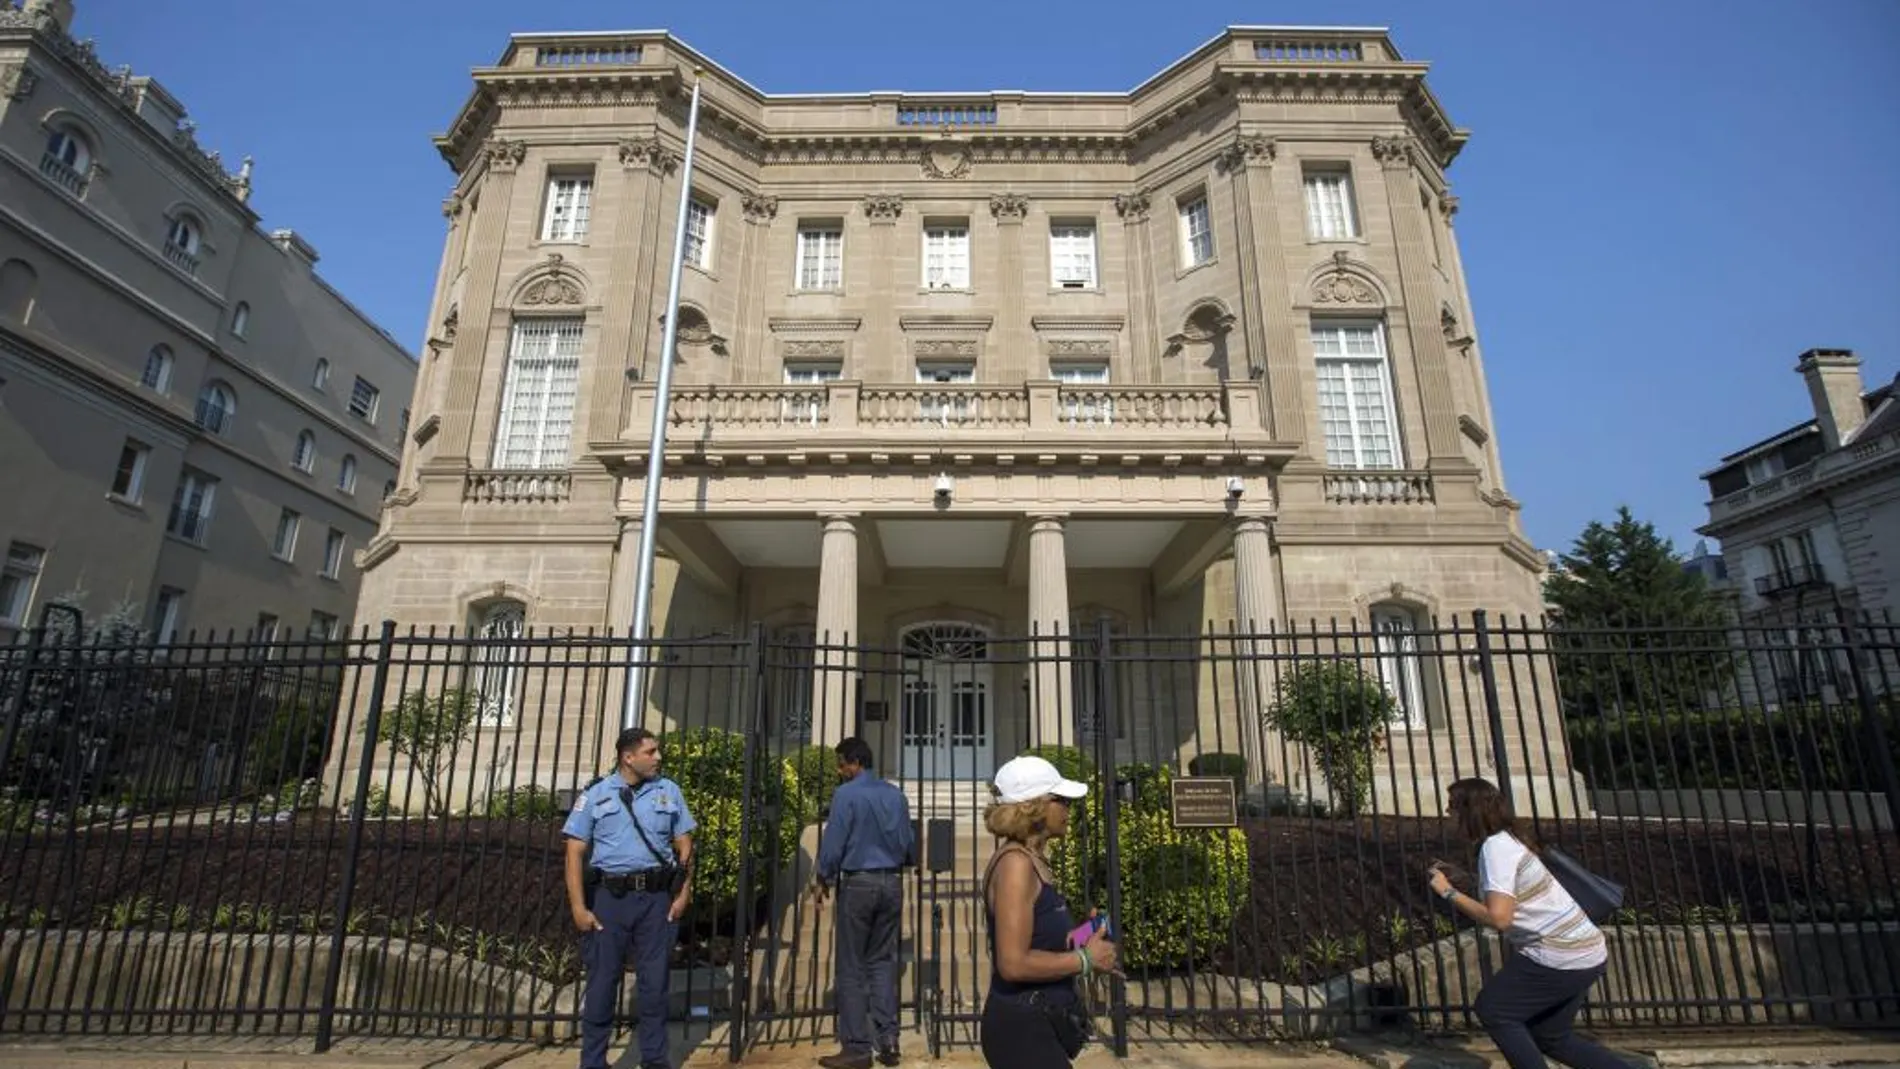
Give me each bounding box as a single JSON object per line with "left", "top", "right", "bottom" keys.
{"left": 1473, "top": 953, "right": 1630, "bottom": 1069}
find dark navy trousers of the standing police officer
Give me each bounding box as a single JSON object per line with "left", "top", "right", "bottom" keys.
{"left": 581, "top": 887, "right": 678, "bottom": 1069}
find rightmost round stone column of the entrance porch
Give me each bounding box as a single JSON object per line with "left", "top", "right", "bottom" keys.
{"left": 1233, "top": 516, "right": 1288, "bottom": 784}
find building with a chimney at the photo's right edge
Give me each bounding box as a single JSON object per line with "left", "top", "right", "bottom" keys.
{"left": 1697, "top": 349, "right": 1900, "bottom": 704}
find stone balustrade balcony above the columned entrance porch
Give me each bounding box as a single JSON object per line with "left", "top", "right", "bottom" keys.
{"left": 623, "top": 380, "right": 1294, "bottom": 465}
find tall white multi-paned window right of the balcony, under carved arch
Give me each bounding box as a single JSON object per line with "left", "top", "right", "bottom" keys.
{"left": 1313, "top": 321, "right": 1404, "bottom": 469}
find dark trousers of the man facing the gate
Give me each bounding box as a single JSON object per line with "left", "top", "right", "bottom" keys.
{"left": 836, "top": 872, "right": 904, "bottom": 1054}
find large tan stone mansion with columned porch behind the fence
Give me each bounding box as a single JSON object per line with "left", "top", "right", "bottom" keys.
{"left": 361, "top": 27, "right": 1562, "bottom": 805}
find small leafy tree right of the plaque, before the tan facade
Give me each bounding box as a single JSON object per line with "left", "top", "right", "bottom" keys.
{"left": 1265, "top": 661, "right": 1398, "bottom": 816}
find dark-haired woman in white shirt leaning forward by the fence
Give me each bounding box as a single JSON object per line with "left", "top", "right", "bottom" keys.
{"left": 1431, "top": 778, "right": 1630, "bottom": 1069}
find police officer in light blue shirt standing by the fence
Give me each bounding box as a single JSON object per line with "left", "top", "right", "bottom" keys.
{"left": 561, "top": 727, "right": 697, "bottom": 1069}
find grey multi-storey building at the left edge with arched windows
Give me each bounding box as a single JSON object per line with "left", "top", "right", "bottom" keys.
{"left": 0, "top": 0, "right": 416, "bottom": 640}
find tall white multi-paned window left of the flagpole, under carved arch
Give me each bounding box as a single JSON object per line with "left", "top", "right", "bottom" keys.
{"left": 494, "top": 319, "right": 581, "bottom": 467}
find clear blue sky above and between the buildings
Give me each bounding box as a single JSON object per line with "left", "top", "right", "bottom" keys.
{"left": 76, "top": 0, "right": 1900, "bottom": 551}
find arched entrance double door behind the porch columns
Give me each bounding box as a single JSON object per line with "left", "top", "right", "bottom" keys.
{"left": 899, "top": 623, "right": 996, "bottom": 780}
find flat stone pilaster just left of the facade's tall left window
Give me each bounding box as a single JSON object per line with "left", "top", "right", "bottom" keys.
{"left": 435, "top": 139, "right": 528, "bottom": 469}
